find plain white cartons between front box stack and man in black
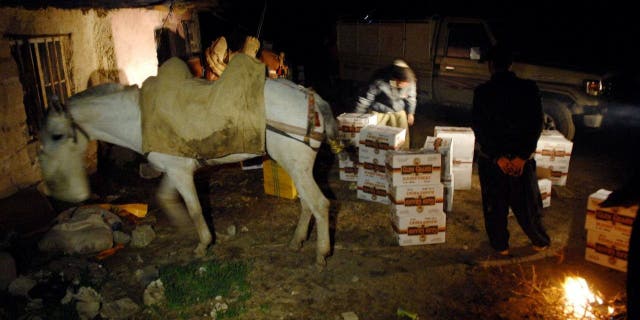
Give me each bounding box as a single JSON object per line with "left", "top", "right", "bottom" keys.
{"left": 434, "top": 126, "right": 476, "bottom": 190}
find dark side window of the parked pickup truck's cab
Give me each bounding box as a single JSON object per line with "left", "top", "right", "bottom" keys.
{"left": 447, "top": 23, "right": 491, "bottom": 59}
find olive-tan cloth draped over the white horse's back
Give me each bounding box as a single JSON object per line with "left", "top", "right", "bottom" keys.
{"left": 141, "top": 53, "right": 266, "bottom": 159}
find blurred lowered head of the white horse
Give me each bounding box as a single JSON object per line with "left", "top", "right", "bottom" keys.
{"left": 38, "top": 98, "right": 90, "bottom": 202}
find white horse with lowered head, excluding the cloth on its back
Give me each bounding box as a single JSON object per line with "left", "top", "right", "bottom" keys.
{"left": 39, "top": 79, "right": 340, "bottom": 266}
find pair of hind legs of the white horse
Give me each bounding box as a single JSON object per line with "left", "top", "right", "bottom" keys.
{"left": 267, "top": 131, "right": 331, "bottom": 266}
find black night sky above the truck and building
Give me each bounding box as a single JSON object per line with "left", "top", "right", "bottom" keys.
{"left": 206, "top": 0, "right": 640, "bottom": 97}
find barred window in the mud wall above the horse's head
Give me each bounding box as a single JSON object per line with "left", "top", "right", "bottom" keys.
{"left": 10, "top": 35, "right": 72, "bottom": 138}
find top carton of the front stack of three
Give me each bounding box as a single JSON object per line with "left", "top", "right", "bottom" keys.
{"left": 385, "top": 150, "right": 442, "bottom": 186}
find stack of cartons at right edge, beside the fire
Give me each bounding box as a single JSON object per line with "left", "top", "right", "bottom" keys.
{"left": 585, "top": 189, "right": 638, "bottom": 272}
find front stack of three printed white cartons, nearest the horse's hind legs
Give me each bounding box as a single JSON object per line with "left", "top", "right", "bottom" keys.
{"left": 386, "top": 149, "right": 446, "bottom": 246}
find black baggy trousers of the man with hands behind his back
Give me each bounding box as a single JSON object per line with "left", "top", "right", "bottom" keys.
{"left": 478, "top": 156, "right": 551, "bottom": 251}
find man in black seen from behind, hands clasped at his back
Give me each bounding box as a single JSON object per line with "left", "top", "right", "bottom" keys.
{"left": 472, "top": 45, "right": 550, "bottom": 256}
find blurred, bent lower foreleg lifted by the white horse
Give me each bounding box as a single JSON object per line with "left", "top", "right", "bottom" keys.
{"left": 156, "top": 175, "right": 192, "bottom": 230}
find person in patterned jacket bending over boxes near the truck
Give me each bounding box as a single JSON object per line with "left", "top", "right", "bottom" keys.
{"left": 354, "top": 60, "right": 417, "bottom": 149}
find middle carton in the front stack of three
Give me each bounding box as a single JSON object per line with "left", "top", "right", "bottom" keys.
{"left": 389, "top": 182, "right": 444, "bottom": 216}
